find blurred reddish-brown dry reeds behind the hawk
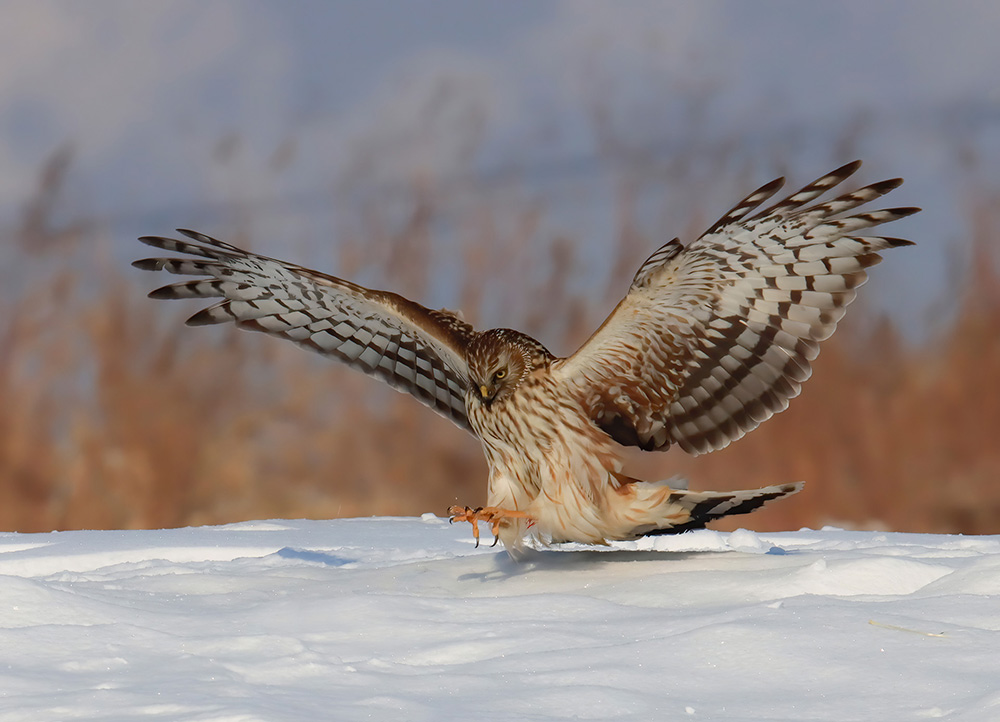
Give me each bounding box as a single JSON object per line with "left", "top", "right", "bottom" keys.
{"left": 0, "top": 142, "right": 1000, "bottom": 533}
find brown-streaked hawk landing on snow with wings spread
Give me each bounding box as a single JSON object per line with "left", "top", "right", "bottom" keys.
{"left": 133, "top": 161, "right": 919, "bottom": 552}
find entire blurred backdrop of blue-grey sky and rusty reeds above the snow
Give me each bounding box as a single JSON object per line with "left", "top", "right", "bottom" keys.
{"left": 0, "top": 0, "right": 1000, "bottom": 533}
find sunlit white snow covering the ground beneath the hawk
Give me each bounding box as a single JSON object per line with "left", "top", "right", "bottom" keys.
{"left": 0, "top": 515, "right": 1000, "bottom": 722}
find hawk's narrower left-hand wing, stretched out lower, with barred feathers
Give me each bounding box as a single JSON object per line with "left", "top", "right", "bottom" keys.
{"left": 132, "top": 230, "right": 476, "bottom": 431}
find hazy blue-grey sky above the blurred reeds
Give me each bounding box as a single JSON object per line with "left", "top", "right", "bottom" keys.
{"left": 0, "top": 0, "right": 1000, "bottom": 335}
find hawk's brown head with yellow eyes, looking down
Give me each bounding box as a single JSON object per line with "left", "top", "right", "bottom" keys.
{"left": 466, "top": 328, "right": 549, "bottom": 405}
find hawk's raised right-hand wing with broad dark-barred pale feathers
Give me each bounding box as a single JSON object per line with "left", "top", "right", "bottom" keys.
{"left": 557, "top": 161, "right": 919, "bottom": 453}
